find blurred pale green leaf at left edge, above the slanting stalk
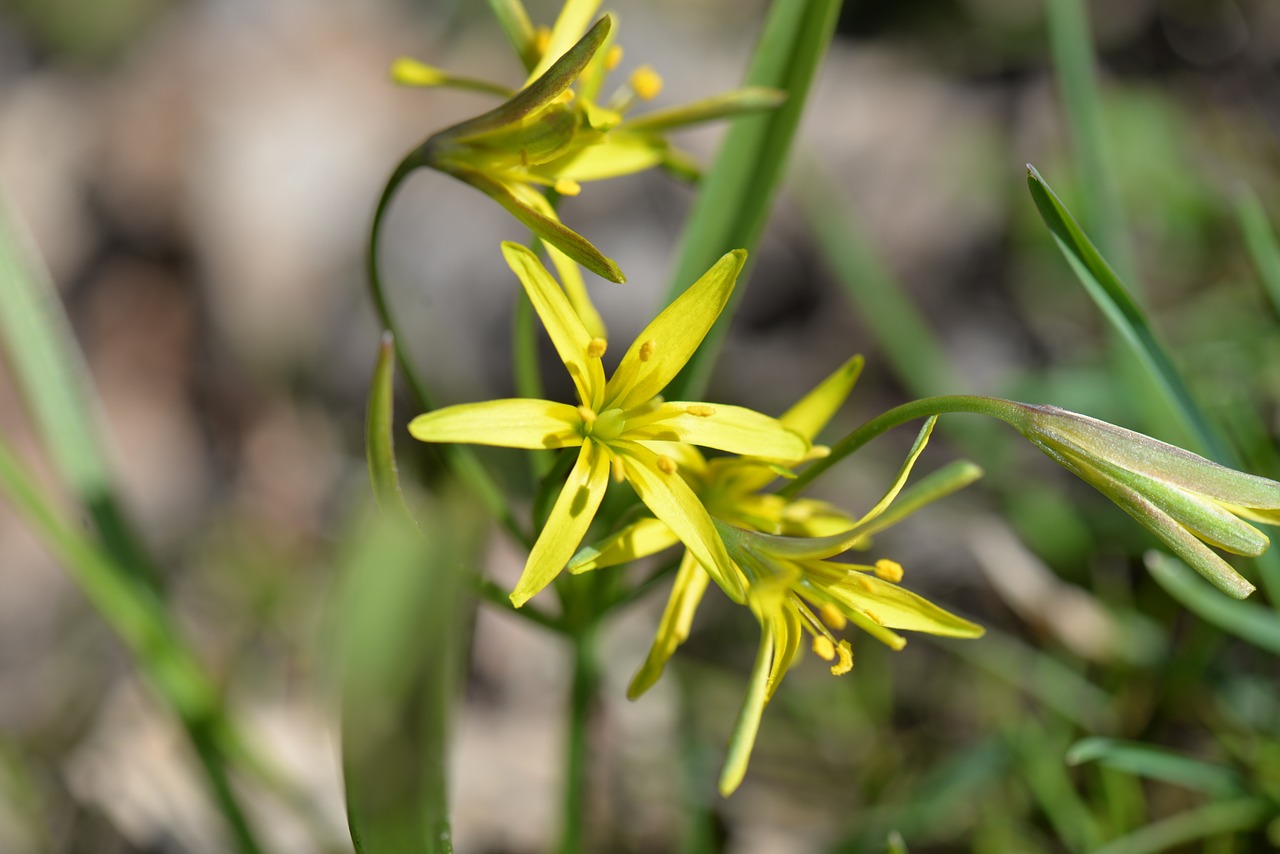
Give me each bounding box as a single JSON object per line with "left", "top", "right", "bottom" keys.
{"left": 0, "top": 197, "right": 157, "bottom": 583}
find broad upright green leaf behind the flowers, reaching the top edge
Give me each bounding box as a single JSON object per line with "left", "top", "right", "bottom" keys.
{"left": 667, "top": 0, "right": 841, "bottom": 401}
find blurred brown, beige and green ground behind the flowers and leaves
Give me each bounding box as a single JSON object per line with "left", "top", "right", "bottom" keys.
{"left": 0, "top": 0, "right": 1280, "bottom": 853}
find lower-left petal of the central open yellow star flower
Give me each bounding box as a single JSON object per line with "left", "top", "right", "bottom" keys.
{"left": 511, "top": 442, "right": 609, "bottom": 608}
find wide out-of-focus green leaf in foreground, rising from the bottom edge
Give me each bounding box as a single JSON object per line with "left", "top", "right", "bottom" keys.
{"left": 334, "top": 497, "right": 476, "bottom": 854}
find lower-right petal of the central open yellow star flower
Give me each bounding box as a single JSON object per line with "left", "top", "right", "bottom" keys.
{"left": 609, "top": 440, "right": 742, "bottom": 602}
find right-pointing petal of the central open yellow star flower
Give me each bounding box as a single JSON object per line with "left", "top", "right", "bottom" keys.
{"left": 623, "top": 402, "right": 809, "bottom": 460}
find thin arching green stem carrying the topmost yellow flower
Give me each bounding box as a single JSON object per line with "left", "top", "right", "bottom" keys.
{"left": 366, "top": 146, "right": 532, "bottom": 548}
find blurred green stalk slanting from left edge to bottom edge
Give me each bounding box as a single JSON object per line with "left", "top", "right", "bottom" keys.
{"left": 0, "top": 439, "right": 261, "bottom": 854}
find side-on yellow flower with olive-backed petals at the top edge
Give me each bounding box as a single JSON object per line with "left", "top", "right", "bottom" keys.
{"left": 392, "top": 0, "right": 785, "bottom": 290}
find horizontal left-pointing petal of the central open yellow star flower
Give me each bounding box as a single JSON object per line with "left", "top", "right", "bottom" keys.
{"left": 408, "top": 398, "right": 582, "bottom": 448}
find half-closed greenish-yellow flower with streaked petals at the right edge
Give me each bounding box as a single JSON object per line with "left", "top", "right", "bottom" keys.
{"left": 992, "top": 401, "right": 1280, "bottom": 599}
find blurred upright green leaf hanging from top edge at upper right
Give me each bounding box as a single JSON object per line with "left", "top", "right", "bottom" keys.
{"left": 1046, "top": 0, "right": 1137, "bottom": 282}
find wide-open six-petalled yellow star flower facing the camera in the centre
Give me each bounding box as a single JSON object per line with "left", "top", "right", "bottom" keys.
{"left": 410, "top": 243, "right": 809, "bottom": 606}
